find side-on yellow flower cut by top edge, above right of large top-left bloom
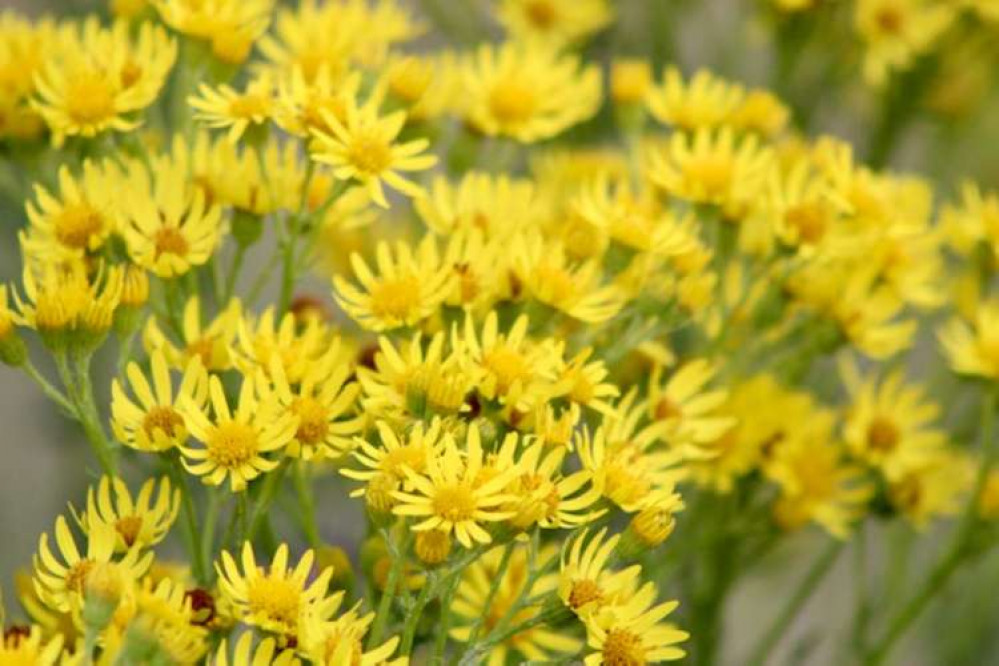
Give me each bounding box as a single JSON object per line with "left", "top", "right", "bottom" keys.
{"left": 150, "top": 0, "right": 274, "bottom": 65}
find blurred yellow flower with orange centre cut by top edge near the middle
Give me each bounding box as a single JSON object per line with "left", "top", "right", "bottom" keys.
{"left": 496, "top": 0, "right": 613, "bottom": 44}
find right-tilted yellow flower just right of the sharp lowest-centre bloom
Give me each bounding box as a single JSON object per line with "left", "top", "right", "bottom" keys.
{"left": 508, "top": 437, "right": 605, "bottom": 530}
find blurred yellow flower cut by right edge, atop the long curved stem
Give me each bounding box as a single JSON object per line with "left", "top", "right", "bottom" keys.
{"left": 938, "top": 300, "right": 999, "bottom": 379}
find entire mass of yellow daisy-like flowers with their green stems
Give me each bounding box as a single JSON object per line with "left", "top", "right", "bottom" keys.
{"left": 0, "top": 0, "right": 999, "bottom": 666}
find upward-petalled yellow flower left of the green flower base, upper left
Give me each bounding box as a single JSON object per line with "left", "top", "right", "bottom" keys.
{"left": 121, "top": 152, "right": 222, "bottom": 279}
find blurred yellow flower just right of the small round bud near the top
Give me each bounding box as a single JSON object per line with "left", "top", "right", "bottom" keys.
{"left": 648, "top": 67, "right": 745, "bottom": 132}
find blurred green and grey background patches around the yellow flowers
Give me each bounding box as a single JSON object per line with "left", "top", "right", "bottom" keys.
{"left": 0, "top": 0, "right": 999, "bottom": 666}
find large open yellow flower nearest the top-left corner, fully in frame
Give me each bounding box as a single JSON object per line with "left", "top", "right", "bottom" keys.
{"left": 32, "top": 17, "right": 177, "bottom": 146}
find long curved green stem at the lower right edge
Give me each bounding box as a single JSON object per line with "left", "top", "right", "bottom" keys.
{"left": 865, "top": 389, "right": 997, "bottom": 666}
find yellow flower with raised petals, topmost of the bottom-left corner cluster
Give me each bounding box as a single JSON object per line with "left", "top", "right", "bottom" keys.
{"left": 74, "top": 476, "right": 180, "bottom": 553}
